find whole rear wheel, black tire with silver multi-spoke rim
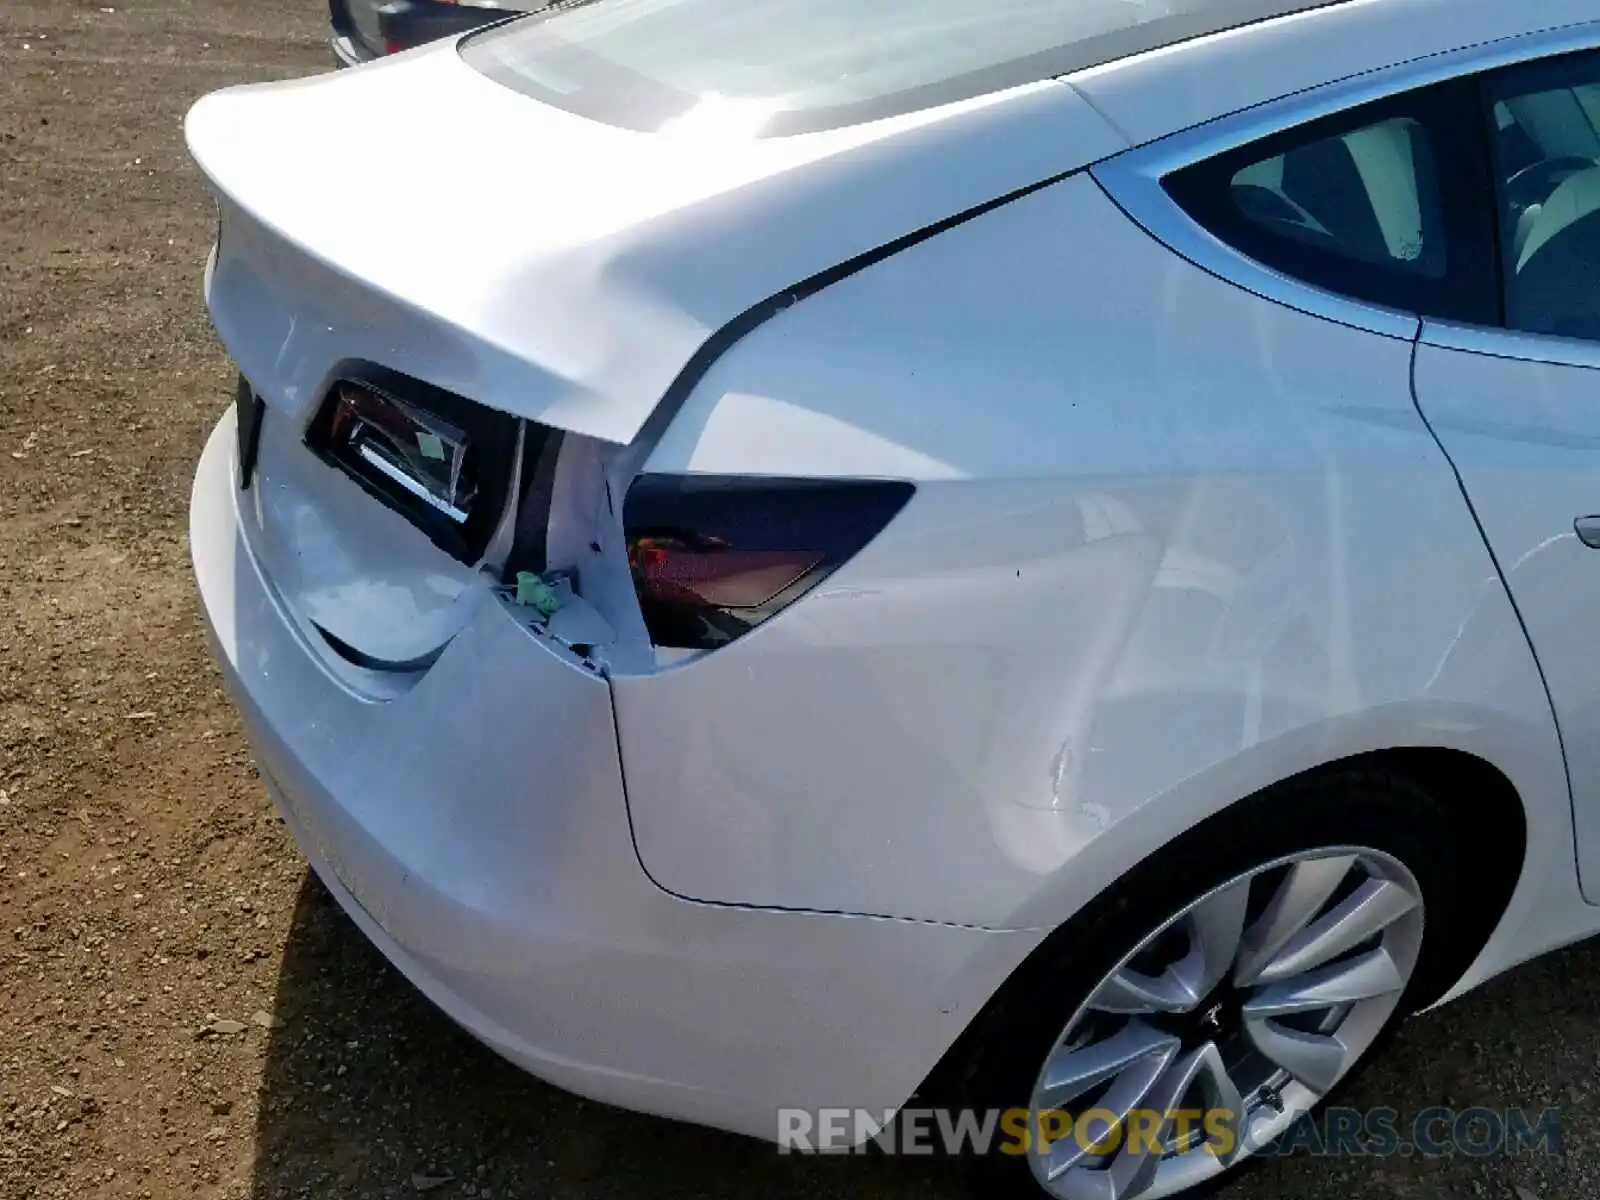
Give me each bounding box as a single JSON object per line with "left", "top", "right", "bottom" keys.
{"left": 962, "top": 771, "right": 1459, "bottom": 1200}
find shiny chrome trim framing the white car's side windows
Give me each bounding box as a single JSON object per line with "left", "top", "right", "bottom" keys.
{"left": 1090, "top": 21, "right": 1600, "bottom": 345}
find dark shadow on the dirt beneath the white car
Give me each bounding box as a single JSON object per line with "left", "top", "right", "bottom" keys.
{"left": 253, "top": 875, "right": 1600, "bottom": 1200}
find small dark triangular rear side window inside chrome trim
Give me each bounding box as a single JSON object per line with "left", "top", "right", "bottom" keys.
{"left": 1165, "top": 86, "right": 1499, "bottom": 322}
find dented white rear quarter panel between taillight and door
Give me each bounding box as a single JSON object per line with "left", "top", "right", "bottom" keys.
{"left": 613, "top": 176, "right": 1571, "bottom": 928}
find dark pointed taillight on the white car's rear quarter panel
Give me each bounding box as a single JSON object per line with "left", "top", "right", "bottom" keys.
{"left": 622, "top": 475, "right": 912, "bottom": 650}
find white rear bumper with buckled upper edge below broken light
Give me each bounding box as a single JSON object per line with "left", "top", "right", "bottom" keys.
{"left": 190, "top": 413, "right": 1037, "bottom": 1138}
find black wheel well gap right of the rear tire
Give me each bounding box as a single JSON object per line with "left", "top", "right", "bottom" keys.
{"left": 1356, "top": 747, "right": 1528, "bottom": 1008}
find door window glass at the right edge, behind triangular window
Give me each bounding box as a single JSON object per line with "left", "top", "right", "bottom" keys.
{"left": 1486, "top": 54, "right": 1600, "bottom": 338}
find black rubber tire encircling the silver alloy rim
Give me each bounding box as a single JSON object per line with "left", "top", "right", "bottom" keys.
{"left": 917, "top": 768, "right": 1462, "bottom": 1197}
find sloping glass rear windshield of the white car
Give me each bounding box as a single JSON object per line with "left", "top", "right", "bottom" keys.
{"left": 461, "top": 0, "right": 1338, "bottom": 136}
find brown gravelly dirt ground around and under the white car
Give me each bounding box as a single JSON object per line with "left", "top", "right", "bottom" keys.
{"left": 0, "top": 0, "right": 1600, "bottom": 1200}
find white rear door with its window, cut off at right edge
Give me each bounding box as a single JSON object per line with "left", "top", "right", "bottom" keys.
{"left": 1413, "top": 51, "right": 1600, "bottom": 902}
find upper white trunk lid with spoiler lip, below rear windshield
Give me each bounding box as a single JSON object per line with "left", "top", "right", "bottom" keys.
{"left": 187, "top": 43, "right": 1125, "bottom": 443}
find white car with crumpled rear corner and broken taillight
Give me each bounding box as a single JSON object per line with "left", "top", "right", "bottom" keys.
{"left": 187, "top": 0, "right": 1600, "bottom": 1200}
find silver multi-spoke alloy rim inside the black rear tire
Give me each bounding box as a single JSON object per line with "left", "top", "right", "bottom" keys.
{"left": 1029, "top": 846, "right": 1424, "bottom": 1200}
